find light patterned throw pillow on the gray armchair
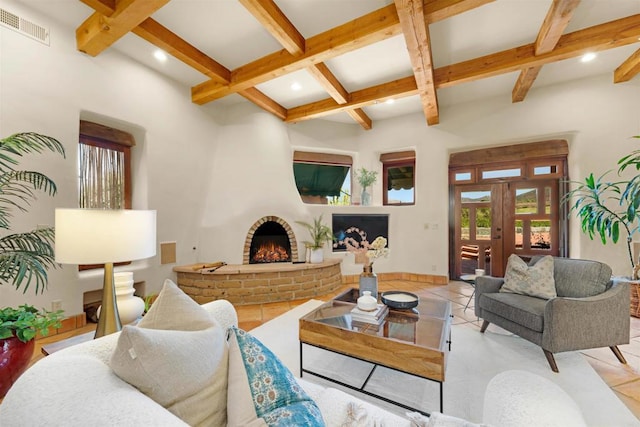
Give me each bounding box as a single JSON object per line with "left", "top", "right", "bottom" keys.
{"left": 500, "top": 254, "right": 557, "bottom": 299}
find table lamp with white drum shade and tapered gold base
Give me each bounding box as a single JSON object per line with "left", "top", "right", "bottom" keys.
{"left": 55, "top": 209, "right": 156, "bottom": 338}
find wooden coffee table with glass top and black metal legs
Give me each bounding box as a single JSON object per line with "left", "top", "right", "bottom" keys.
{"left": 299, "top": 289, "right": 452, "bottom": 414}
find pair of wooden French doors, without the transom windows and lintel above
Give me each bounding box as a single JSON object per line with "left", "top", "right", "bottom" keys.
{"left": 454, "top": 180, "right": 560, "bottom": 277}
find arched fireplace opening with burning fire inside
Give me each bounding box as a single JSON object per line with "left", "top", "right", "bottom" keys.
{"left": 249, "top": 221, "right": 291, "bottom": 264}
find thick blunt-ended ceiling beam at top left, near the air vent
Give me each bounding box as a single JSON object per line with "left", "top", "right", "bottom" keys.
{"left": 76, "top": 0, "right": 169, "bottom": 56}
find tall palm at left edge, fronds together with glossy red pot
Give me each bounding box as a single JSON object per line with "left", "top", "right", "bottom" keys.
{"left": 0, "top": 132, "right": 64, "bottom": 398}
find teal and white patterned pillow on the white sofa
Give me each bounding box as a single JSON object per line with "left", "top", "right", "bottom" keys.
{"left": 227, "top": 327, "right": 324, "bottom": 427}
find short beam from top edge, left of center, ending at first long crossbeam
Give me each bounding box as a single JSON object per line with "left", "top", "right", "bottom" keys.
{"left": 240, "top": 0, "right": 305, "bottom": 55}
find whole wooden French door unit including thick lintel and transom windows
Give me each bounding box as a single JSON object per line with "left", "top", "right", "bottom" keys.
{"left": 449, "top": 141, "right": 568, "bottom": 278}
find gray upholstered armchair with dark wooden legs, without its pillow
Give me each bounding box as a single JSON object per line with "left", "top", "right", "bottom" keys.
{"left": 475, "top": 257, "right": 630, "bottom": 372}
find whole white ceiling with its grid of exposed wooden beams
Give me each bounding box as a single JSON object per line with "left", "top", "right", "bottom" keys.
{"left": 13, "top": 0, "right": 640, "bottom": 129}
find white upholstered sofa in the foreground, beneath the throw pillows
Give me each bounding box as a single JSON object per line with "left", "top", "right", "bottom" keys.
{"left": 0, "top": 300, "right": 581, "bottom": 427}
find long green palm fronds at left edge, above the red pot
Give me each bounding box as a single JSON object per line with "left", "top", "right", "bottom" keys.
{"left": 0, "top": 132, "right": 65, "bottom": 294}
